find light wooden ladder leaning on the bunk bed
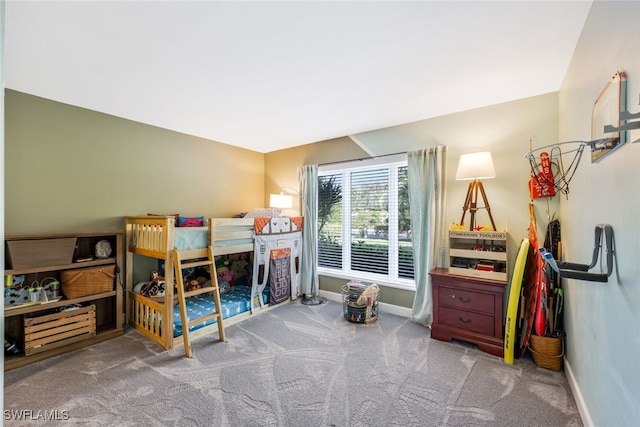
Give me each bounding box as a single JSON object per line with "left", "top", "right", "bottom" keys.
{"left": 173, "top": 246, "right": 226, "bottom": 358}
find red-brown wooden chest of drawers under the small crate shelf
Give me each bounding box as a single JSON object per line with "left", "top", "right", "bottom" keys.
{"left": 430, "top": 268, "right": 506, "bottom": 357}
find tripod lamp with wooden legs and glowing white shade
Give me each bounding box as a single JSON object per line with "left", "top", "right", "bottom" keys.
{"left": 456, "top": 151, "right": 496, "bottom": 231}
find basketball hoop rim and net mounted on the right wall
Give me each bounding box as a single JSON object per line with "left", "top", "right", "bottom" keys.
{"left": 525, "top": 141, "right": 593, "bottom": 199}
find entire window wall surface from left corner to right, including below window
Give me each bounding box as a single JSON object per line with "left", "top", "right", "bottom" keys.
{"left": 265, "top": 92, "right": 558, "bottom": 307}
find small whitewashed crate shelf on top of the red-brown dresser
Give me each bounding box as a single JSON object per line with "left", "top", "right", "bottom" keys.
{"left": 449, "top": 230, "right": 508, "bottom": 282}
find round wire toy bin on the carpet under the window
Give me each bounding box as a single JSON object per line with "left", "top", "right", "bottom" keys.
{"left": 342, "top": 282, "right": 380, "bottom": 323}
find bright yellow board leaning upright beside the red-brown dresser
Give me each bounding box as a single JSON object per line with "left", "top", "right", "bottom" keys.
{"left": 504, "top": 239, "right": 529, "bottom": 365}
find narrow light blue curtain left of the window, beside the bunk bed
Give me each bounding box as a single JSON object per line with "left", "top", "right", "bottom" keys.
{"left": 298, "top": 165, "right": 320, "bottom": 298}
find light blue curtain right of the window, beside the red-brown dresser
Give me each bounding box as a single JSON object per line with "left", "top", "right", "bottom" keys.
{"left": 407, "top": 145, "right": 447, "bottom": 326}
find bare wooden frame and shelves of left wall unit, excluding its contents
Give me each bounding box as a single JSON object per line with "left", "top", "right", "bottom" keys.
{"left": 4, "top": 230, "right": 124, "bottom": 371}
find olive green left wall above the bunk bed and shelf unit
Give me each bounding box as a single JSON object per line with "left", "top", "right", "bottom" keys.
{"left": 4, "top": 90, "right": 265, "bottom": 234}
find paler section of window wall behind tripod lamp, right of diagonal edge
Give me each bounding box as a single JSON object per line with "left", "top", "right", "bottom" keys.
{"left": 356, "top": 92, "right": 559, "bottom": 252}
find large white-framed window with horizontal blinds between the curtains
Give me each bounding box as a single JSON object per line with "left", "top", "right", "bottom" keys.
{"left": 318, "top": 156, "right": 415, "bottom": 288}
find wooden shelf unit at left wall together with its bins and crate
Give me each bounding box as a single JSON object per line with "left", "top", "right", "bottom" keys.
{"left": 4, "top": 231, "right": 124, "bottom": 371}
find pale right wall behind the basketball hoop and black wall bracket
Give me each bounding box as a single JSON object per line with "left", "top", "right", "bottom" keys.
{"left": 559, "top": 1, "right": 640, "bottom": 426}
